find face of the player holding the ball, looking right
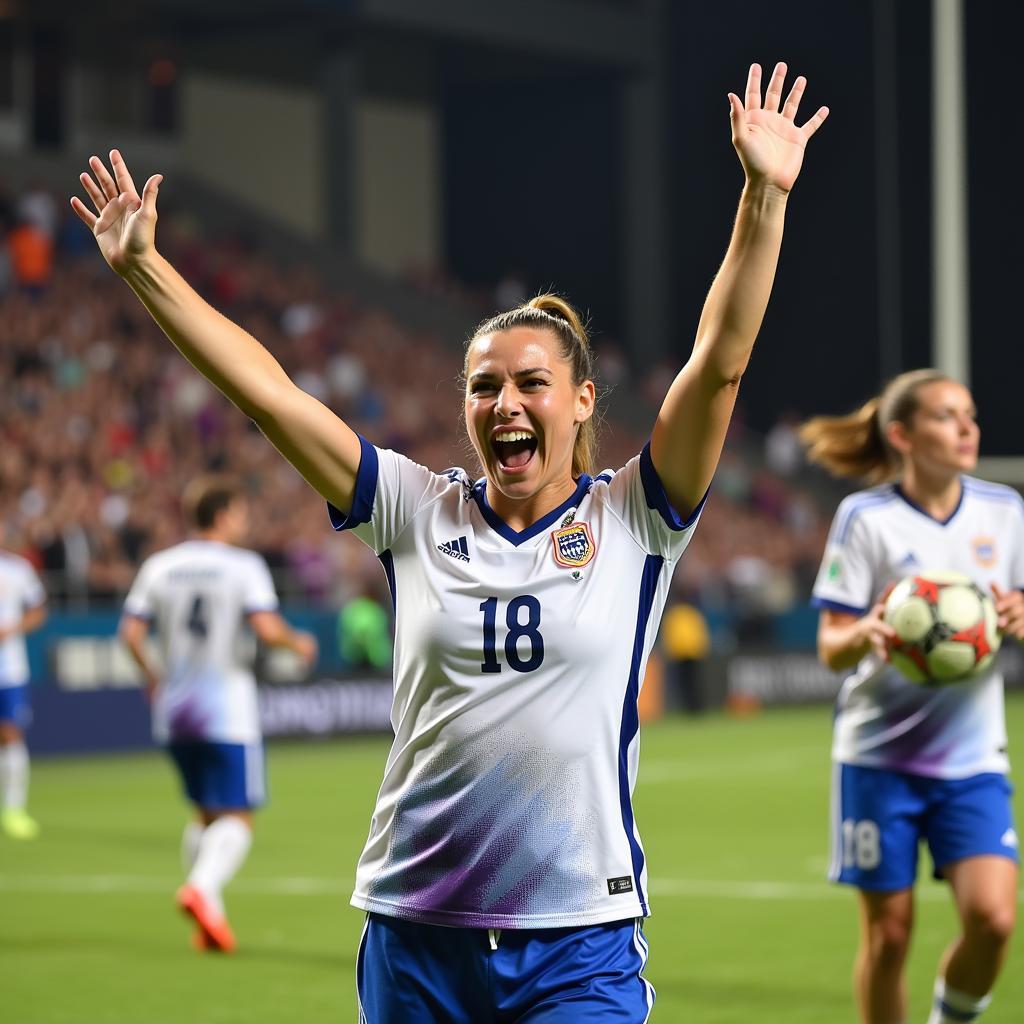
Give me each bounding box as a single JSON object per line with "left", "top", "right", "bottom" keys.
{"left": 890, "top": 381, "right": 981, "bottom": 476}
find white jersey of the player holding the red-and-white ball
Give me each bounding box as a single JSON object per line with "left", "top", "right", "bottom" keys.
{"left": 814, "top": 477, "right": 1024, "bottom": 778}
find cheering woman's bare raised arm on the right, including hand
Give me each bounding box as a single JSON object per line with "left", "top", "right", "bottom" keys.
{"left": 650, "top": 63, "right": 828, "bottom": 514}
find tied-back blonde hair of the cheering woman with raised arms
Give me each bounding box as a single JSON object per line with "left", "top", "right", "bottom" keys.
{"left": 463, "top": 293, "right": 597, "bottom": 477}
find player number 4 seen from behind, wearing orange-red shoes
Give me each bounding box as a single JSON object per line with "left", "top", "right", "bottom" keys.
{"left": 121, "top": 477, "right": 316, "bottom": 952}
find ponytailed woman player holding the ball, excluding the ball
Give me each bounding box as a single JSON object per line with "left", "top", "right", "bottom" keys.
{"left": 803, "top": 370, "right": 1024, "bottom": 1024}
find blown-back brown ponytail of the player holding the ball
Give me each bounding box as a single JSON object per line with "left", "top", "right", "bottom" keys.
{"left": 800, "top": 370, "right": 951, "bottom": 483}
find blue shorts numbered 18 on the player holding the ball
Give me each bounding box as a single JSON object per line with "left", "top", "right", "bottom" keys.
{"left": 828, "top": 765, "right": 1020, "bottom": 892}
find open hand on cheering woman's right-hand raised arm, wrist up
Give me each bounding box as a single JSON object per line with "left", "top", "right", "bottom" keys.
{"left": 729, "top": 61, "right": 828, "bottom": 193}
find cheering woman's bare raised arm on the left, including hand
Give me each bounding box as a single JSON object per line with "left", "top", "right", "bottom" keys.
{"left": 71, "top": 150, "right": 359, "bottom": 513}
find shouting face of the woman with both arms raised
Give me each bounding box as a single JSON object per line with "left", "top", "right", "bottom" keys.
{"left": 466, "top": 327, "right": 594, "bottom": 498}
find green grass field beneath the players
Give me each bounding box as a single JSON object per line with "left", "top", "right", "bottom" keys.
{"left": 0, "top": 697, "right": 1024, "bottom": 1024}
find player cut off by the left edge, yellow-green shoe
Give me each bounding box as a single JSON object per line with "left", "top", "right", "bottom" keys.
{"left": 0, "top": 551, "right": 46, "bottom": 839}
